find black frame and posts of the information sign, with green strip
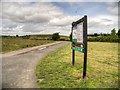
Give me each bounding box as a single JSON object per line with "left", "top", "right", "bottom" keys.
{"left": 72, "top": 15, "right": 87, "bottom": 78}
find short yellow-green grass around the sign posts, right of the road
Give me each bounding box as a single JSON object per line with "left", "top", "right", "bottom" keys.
{"left": 36, "top": 42, "right": 118, "bottom": 88}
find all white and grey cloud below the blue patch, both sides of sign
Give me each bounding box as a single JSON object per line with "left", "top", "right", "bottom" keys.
{"left": 2, "top": 2, "right": 118, "bottom": 35}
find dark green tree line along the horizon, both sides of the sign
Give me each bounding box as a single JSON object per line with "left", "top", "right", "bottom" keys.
{"left": 3, "top": 28, "right": 120, "bottom": 42}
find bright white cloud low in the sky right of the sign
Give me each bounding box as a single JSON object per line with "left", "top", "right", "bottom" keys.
{"left": 88, "top": 15, "right": 118, "bottom": 33}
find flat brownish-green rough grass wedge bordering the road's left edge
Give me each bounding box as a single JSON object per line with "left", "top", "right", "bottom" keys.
{"left": 0, "top": 38, "right": 54, "bottom": 52}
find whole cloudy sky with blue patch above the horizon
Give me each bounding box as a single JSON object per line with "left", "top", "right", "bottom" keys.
{"left": 0, "top": 2, "right": 118, "bottom": 36}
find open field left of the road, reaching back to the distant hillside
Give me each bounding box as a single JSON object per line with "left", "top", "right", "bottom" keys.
{"left": 0, "top": 34, "right": 69, "bottom": 52}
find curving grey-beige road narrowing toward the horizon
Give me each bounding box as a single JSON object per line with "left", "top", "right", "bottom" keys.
{"left": 2, "top": 42, "right": 68, "bottom": 88}
